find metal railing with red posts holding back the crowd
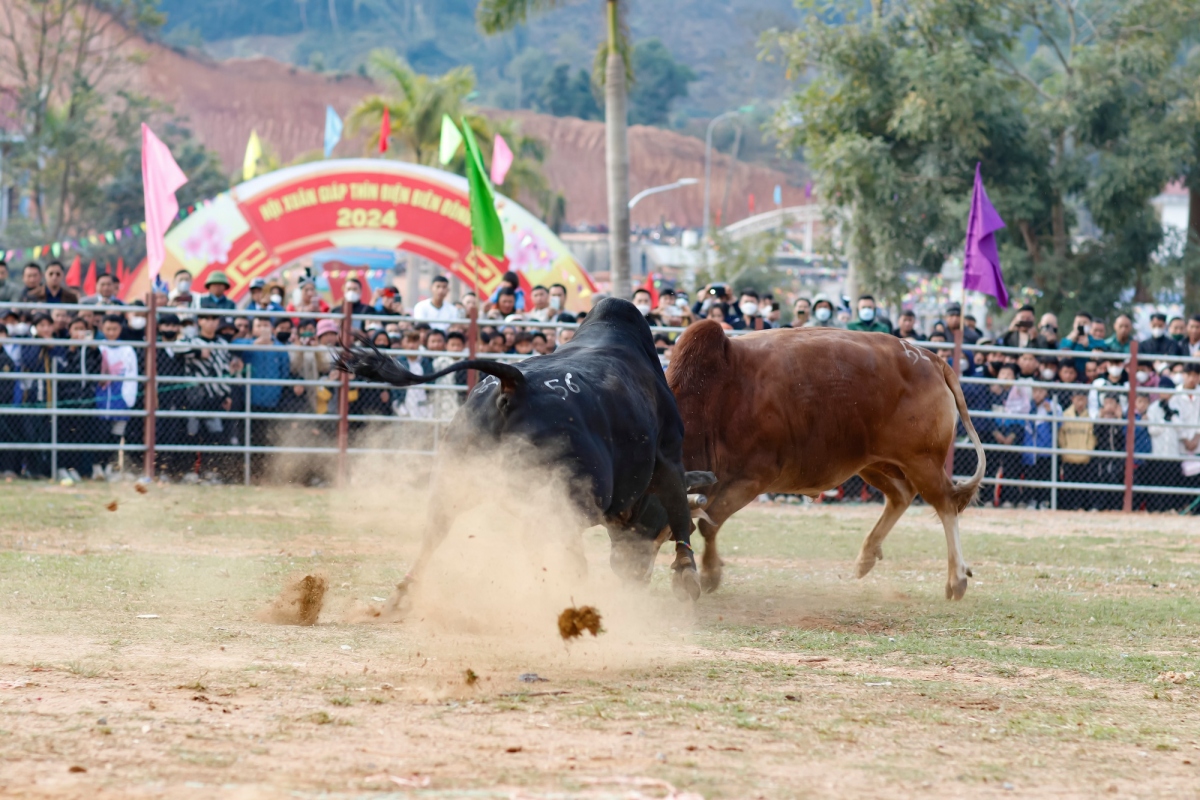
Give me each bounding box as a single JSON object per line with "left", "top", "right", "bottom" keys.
{"left": 0, "top": 303, "right": 1200, "bottom": 510}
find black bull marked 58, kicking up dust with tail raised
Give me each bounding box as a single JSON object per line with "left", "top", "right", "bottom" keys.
{"left": 338, "top": 297, "right": 712, "bottom": 603}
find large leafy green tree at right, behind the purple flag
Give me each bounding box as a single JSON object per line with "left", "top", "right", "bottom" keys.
{"left": 778, "top": 0, "right": 1196, "bottom": 313}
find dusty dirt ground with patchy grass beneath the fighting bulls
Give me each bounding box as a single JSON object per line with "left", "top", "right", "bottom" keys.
{"left": 0, "top": 483, "right": 1200, "bottom": 800}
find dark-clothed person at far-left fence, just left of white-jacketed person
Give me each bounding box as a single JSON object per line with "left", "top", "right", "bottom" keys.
{"left": 55, "top": 317, "right": 101, "bottom": 485}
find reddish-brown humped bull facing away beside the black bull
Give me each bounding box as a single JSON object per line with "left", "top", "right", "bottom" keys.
{"left": 667, "top": 320, "right": 985, "bottom": 600}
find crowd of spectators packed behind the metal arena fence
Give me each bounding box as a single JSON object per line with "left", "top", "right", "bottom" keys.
{"left": 0, "top": 261, "right": 1200, "bottom": 509}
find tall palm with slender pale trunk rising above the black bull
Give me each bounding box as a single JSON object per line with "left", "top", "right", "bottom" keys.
{"left": 476, "top": 0, "right": 632, "bottom": 297}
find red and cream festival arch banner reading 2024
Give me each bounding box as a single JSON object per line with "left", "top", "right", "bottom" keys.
{"left": 122, "top": 158, "right": 596, "bottom": 308}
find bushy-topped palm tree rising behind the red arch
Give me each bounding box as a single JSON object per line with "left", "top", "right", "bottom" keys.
{"left": 347, "top": 50, "right": 475, "bottom": 166}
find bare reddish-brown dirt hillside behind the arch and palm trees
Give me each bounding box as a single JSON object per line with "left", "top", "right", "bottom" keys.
{"left": 137, "top": 44, "right": 805, "bottom": 227}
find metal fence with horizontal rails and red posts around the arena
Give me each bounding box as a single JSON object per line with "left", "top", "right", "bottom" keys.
{"left": 0, "top": 303, "right": 1200, "bottom": 512}
